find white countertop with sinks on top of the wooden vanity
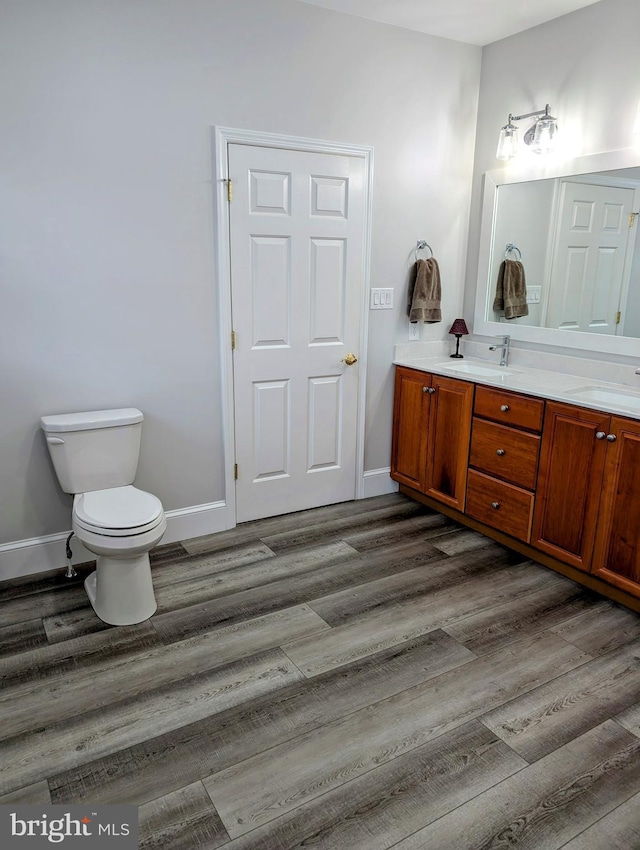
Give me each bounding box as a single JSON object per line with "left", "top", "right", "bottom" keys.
{"left": 393, "top": 355, "right": 640, "bottom": 419}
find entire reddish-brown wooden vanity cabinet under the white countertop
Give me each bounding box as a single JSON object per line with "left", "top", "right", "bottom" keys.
{"left": 391, "top": 366, "right": 640, "bottom": 611}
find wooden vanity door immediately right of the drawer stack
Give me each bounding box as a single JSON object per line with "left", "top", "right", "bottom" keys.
{"left": 531, "top": 402, "right": 610, "bottom": 572}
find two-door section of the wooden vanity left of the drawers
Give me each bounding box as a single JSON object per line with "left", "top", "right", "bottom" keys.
{"left": 391, "top": 366, "right": 474, "bottom": 511}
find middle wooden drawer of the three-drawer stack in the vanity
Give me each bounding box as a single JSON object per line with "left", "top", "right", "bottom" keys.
{"left": 469, "top": 417, "right": 540, "bottom": 490}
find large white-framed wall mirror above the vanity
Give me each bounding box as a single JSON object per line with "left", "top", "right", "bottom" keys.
{"left": 474, "top": 150, "right": 640, "bottom": 357}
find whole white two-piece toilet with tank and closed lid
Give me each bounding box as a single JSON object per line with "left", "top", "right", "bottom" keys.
{"left": 40, "top": 407, "right": 167, "bottom": 626}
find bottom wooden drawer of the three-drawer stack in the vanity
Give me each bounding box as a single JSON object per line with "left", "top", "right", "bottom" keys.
{"left": 465, "top": 469, "right": 533, "bottom": 543}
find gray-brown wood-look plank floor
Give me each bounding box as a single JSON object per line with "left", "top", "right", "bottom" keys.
{"left": 0, "top": 495, "right": 640, "bottom": 850}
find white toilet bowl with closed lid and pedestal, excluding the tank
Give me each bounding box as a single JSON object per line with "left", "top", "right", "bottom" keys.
{"left": 71, "top": 485, "right": 167, "bottom": 626}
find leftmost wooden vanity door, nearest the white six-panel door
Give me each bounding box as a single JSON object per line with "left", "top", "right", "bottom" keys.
{"left": 391, "top": 366, "right": 431, "bottom": 491}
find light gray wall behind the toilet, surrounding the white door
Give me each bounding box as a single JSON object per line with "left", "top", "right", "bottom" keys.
{"left": 0, "top": 0, "right": 480, "bottom": 542}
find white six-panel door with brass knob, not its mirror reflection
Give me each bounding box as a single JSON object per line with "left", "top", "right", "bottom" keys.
{"left": 228, "top": 144, "right": 365, "bottom": 522}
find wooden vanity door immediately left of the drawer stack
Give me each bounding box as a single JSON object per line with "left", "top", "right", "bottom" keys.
{"left": 424, "top": 375, "right": 474, "bottom": 511}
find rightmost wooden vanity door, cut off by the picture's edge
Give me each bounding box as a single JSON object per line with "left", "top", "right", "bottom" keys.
{"left": 592, "top": 416, "right": 640, "bottom": 596}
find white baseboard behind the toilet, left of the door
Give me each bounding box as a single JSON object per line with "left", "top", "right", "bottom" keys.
{"left": 0, "top": 502, "right": 227, "bottom": 581}
